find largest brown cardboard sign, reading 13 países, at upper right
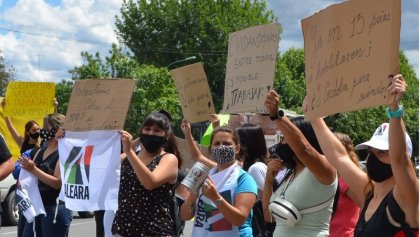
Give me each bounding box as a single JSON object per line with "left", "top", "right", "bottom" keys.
{"left": 302, "top": 0, "right": 401, "bottom": 119}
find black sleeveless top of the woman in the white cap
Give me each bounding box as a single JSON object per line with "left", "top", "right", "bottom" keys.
{"left": 354, "top": 190, "right": 418, "bottom": 237}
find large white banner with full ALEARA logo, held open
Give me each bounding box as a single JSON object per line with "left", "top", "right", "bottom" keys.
{"left": 58, "top": 130, "right": 121, "bottom": 211}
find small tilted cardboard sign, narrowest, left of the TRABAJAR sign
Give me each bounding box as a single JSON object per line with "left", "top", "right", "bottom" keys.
{"left": 171, "top": 63, "right": 216, "bottom": 123}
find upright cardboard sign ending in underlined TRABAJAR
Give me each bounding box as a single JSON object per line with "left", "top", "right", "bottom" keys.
{"left": 223, "top": 24, "right": 280, "bottom": 113}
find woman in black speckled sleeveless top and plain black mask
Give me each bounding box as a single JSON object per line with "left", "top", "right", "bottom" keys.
{"left": 112, "top": 112, "right": 182, "bottom": 236}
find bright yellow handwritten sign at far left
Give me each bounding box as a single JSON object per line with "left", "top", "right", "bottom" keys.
{"left": 4, "top": 81, "right": 55, "bottom": 117}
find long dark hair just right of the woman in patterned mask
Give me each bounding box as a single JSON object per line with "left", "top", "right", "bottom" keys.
{"left": 235, "top": 123, "right": 268, "bottom": 171}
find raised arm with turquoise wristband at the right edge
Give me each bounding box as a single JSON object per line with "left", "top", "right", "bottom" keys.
{"left": 388, "top": 75, "right": 419, "bottom": 228}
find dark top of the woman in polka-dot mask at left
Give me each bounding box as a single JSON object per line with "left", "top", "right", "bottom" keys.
{"left": 34, "top": 147, "right": 60, "bottom": 207}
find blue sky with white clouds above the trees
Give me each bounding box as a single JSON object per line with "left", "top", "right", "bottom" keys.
{"left": 0, "top": 0, "right": 419, "bottom": 82}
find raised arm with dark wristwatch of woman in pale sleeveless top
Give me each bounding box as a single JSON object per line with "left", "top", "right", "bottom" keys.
{"left": 264, "top": 90, "right": 336, "bottom": 185}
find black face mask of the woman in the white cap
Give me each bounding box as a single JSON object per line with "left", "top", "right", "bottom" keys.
{"left": 366, "top": 152, "right": 393, "bottom": 183}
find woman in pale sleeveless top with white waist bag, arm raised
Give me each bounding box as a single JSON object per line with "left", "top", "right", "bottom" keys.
{"left": 262, "top": 90, "right": 337, "bottom": 237}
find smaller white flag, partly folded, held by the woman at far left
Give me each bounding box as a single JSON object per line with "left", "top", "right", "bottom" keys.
{"left": 16, "top": 169, "right": 45, "bottom": 223}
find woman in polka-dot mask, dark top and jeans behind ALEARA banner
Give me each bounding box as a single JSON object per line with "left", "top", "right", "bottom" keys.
{"left": 19, "top": 113, "right": 73, "bottom": 237}
